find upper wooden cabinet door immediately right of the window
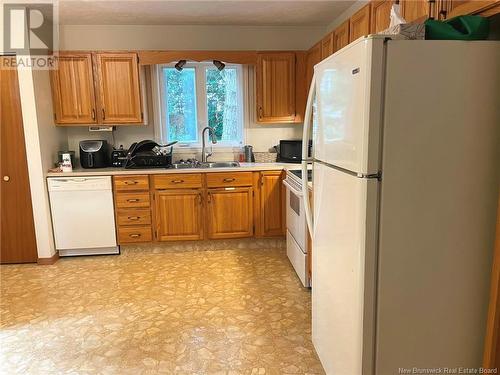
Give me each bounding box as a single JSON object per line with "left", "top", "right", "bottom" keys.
{"left": 256, "top": 52, "right": 295, "bottom": 123}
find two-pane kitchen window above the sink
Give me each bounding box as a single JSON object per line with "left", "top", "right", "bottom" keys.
{"left": 158, "top": 62, "right": 244, "bottom": 148}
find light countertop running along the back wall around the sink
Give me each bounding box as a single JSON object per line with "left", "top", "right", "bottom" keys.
{"left": 46, "top": 163, "right": 300, "bottom": 177}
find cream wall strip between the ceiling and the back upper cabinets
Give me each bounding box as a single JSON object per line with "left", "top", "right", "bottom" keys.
{"left": 60, "top": 25, "right": 325, "bottom": 50}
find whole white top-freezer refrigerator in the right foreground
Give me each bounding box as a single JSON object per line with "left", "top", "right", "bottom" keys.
{"left": 303, "top": 36, "right": 500, "bottom": 375}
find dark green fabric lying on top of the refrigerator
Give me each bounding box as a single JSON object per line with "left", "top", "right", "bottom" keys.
{"left": 425, "top": 16, "right": 490, "bottom": 40}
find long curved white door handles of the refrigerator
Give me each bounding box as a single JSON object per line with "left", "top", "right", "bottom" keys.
{"left": 302, "top": 74, "right": 316, "bottom": 238}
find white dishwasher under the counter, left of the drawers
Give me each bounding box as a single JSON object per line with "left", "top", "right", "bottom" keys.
{"left": 47, "top": 176, "right": 120, "bottom": 256}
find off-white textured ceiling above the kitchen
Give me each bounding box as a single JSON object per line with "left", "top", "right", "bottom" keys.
{"left": 59, "top": 0, "right": 353, "bottom": 26}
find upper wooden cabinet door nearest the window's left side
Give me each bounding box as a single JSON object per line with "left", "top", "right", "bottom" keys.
{"left": 96, "top": 53, "right": 143, "bottom": 124}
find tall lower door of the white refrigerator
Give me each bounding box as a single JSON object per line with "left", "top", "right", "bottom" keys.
{"left": 312, "top": 163, "right": 378, "bottom": 375}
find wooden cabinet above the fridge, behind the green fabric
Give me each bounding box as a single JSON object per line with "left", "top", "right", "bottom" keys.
{"left": 439, "top": 0, "right": 500, "bottom": 19}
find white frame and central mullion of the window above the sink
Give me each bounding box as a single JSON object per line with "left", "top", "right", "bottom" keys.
{"left": 156, "top": 62, "right": 248, "bottom": 150}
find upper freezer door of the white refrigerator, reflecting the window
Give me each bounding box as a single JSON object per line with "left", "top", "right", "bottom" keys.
{"left": 313, "top": 38, "right": 384, "bottom": 174}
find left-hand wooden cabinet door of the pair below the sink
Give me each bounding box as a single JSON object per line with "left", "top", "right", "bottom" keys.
{"left": 155, "top": 189, "right": 203, "bottom": 241}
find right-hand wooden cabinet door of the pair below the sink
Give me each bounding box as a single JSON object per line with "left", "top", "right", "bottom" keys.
{"left": 207, "top": 187, "right": 253, "bottom": 239}
